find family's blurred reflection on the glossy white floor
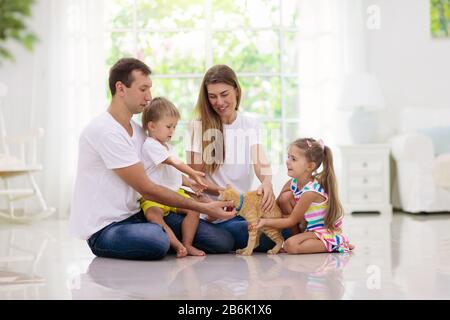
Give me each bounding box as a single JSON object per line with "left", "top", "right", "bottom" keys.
{"left": 71, "top": 254, "right": 351, "bottom": 300}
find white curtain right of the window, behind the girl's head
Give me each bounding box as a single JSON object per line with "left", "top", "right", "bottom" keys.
{"left": 299, "top": 0, "right": 366, "bottom": 146}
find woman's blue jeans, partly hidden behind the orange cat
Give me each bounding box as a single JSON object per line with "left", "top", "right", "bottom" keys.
{"left": 216, "top": 216, "right": 291, "bottom": 252}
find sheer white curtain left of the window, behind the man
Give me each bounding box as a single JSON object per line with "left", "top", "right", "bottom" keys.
{"left": 31, "top": 0, "right": 107, "bottom": 218}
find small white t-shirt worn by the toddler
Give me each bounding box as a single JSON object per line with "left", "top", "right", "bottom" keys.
{"left": 142, "top": 137, "right": 183, "bottom": 192}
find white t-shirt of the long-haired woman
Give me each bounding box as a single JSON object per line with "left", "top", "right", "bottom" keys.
{"left": 186, "top": 112, "right": 261, "bottom": 222}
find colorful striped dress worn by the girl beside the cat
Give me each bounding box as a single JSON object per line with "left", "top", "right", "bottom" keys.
{"left": 291, "top": 178, "right": 350, "bottom": 253}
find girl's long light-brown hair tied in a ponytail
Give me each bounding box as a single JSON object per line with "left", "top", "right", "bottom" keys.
{"left": 291, "top": 138, "right": 343, "bottom": 230}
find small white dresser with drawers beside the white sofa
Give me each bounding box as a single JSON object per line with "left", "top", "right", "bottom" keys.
{"left": 338, "top": 144, "right": 392, "bottom": 219}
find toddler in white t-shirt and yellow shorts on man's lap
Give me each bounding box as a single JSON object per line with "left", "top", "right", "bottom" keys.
{"left": 141, "top": 97, "right": 207, "bottom": 258}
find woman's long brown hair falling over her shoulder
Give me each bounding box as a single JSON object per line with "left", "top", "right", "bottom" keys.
{"left": 192, "top": 65, "right": 241, "bottom": 174}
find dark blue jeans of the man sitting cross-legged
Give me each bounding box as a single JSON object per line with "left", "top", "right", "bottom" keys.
{"left": 87, "top": 211, "right": 234, "bottom": 260}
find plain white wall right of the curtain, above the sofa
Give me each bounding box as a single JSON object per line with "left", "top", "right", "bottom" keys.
{"left": 364, "top": 0, "right": 450, "bottom": 138}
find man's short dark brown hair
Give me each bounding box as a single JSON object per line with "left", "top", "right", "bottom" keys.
{"left": 109, "top": 58, "right": 152, "bottom": 96}
